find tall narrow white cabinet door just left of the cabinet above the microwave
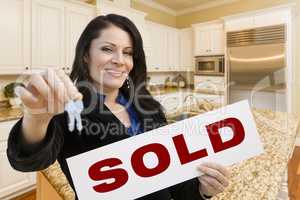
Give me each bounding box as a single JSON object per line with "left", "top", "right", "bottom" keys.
{"left": 179, "top": 28, "right": 194, "bottom": 71}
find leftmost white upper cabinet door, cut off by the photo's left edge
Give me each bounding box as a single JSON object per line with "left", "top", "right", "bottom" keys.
{"left": 0, "top": 0, "right": 30, "bottom": 74}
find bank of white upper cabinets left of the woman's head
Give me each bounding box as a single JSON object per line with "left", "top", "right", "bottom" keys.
{"left": 0, "top": 0, "right": 96, "bottom": 74}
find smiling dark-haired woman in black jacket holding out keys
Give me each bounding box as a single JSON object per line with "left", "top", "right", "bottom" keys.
{"left": 7, "top": 14, "right": 228, "bottom": 200}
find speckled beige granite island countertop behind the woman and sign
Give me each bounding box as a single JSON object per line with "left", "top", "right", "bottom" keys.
{"left": 42, "top": 106, "right": 299, "bottom": 200}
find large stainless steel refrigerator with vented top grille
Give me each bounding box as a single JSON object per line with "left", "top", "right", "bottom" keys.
{"left": 227, "top": 25, "right": 287, "bottom": 111}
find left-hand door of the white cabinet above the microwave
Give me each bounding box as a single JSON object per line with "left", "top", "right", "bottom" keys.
{"left": 194, "top": 29, "right": 211, "bottom": 56}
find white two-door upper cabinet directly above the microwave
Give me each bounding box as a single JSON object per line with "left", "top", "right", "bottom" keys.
{"left": 193, "top": 22, "right": 224, "bottom": 56}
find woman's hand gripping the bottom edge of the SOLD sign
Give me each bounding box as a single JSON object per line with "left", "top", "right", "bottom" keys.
{"left": 198, "top": 163, "right": 230, "bottom": 196}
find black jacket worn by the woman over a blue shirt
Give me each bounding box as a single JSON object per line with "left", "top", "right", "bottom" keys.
{"left": 7, "top": 88, "right": 202, "bottom": 200}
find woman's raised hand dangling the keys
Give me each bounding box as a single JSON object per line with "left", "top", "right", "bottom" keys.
{"left": 15, "top": 69, "right": 81, "bottom": 118}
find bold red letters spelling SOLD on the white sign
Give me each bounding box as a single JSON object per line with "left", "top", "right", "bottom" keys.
{"left": 88, "top": 118, "right": 245, "bottom": 193}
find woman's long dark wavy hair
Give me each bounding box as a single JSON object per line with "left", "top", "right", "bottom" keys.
{"left": 70, "top": 14, "right": 163, "bottom": 121}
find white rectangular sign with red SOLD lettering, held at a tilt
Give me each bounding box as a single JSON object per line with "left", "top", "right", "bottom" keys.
{"left": 67, "top": 101, "right": 263, "bottom": 200}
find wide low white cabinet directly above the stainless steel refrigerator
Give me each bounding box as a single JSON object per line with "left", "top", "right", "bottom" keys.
{"left": 224, "top": 10, "right": 289, "bottom": 31}
